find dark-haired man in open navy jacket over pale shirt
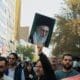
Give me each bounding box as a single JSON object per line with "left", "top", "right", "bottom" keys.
{"left": 5, "top": 53, "right": 26, "bottom": 80}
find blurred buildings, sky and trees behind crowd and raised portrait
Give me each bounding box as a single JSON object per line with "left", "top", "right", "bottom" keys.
{"left": 0, "top": 0, "right": 80, "bottom": 60}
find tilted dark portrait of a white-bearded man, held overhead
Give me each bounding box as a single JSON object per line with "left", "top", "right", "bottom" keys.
{"left": 28, "top": 13, "right": 55, "bottom": 47}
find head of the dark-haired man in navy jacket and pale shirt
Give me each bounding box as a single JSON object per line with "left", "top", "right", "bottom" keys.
{"left": 8, "top": 53, "right": 18, "bottom": 66}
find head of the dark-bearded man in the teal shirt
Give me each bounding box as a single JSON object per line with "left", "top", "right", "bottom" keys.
{"left": 62, "top": 53, "right": 73, "bottom": 71}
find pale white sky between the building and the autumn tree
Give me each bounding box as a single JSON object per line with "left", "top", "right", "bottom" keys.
{"left": 20, "top": 0, "right": 63, "bottom": 56}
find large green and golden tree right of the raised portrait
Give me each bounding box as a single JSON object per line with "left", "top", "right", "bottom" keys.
{"left": 53, "top": 0, "right": 80, "bottom": 55}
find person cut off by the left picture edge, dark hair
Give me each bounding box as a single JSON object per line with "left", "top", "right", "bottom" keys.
{"left": 0, "top": 56, "right": 13, "bottom": 80}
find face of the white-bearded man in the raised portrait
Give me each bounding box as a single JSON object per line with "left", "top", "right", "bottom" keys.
{"left": 37, "top": 25, "right": 49, "bottom": 37}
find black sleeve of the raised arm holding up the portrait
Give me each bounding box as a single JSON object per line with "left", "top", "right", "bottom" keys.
{"left": 39, "top": 53, "right": 56, "bottom": 80}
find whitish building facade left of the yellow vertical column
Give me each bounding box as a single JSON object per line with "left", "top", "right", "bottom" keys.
{"left": 0, "top": 0, "right": 16, "bottom": 53}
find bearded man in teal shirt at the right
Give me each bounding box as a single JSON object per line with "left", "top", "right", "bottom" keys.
{"left": 55, "top": 52, "right": 79, "bottom": 80}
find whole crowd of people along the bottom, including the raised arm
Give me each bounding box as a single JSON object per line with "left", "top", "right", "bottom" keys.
{"left": 0, "top": 46, "right": 80, "bottom": 80}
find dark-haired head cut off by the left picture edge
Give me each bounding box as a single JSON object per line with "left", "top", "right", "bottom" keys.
{"left": 0, "top": 57, "right": 7, "bottom": 77}
